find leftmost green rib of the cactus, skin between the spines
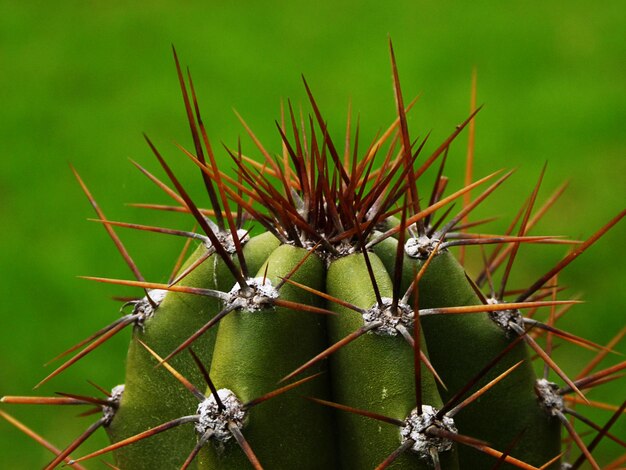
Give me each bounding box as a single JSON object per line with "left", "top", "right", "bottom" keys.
{"left": 108, "top": 233, "right": 278, "bottom": 469}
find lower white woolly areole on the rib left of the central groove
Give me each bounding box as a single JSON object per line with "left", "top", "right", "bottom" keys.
{"left": 196, "top": 388, "right": 246, "bottom": 442}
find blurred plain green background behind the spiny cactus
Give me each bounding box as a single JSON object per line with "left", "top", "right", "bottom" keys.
{"left": 0, "top": 0, "right": 626, "bottom": 469}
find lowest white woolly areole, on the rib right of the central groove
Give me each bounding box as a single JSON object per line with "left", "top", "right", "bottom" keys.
{"left": 400, "top": 405, "right": 457, "bottom": 458}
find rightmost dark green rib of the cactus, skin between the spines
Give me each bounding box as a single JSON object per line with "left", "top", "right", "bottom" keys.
{"left": 375, "top": 240, "right": 560, "bottom": 468}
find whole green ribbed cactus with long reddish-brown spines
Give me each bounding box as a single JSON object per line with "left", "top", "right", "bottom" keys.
{"left": 0, "top": 46, "right": 626, "bottom": 470}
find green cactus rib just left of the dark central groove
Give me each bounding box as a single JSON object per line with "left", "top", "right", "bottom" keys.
{"left": 200, "top": 245, "right": 335, "bottom": 469}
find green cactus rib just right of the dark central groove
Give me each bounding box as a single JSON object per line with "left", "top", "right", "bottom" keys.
{"left": 327, "top": 254, "right": 457, "bottom": 469}
